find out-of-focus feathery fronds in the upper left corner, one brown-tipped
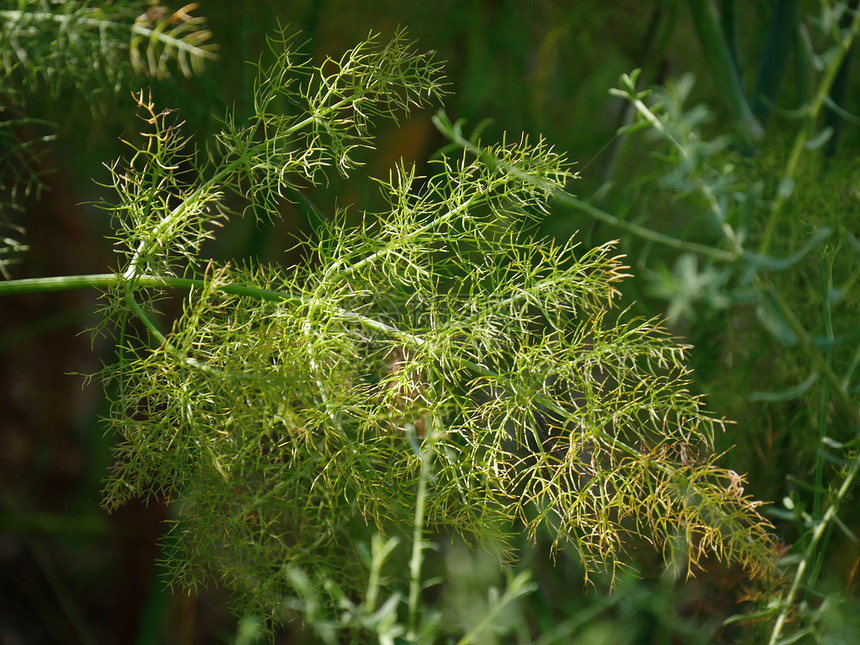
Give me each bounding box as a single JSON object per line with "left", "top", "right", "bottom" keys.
{"left": 0, "top": 0, "right": 215, "bottom": 278}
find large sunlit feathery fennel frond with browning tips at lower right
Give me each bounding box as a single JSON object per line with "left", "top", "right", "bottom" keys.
{"left": 95, "top": 28, "right": 773, "bottom": 616}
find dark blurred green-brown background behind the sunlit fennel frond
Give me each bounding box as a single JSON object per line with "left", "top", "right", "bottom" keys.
{"left": 0, "top": 0, "right": 860, "bottom": 644}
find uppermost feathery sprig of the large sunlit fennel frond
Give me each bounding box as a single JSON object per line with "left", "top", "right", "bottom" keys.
{"left": 218, "top": 31, "right": 444, "bottom": 212}
